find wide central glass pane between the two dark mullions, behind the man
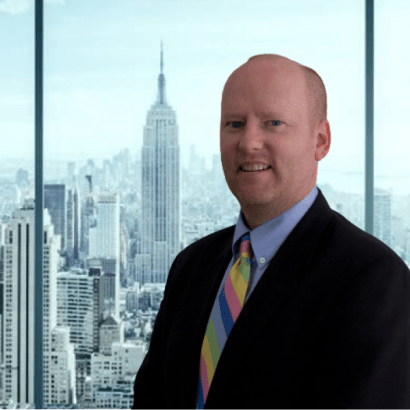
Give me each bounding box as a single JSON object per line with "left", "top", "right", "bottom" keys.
{"left": 45, "top": 0, "right": 364, "bottom": 408}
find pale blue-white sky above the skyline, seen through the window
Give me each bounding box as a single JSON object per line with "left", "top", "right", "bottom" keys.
{"left": 0, "top": 0, "right": 410, "bottom": 185}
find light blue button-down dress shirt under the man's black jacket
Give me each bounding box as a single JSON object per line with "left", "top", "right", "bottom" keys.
{"left": 214, "top": 186, "right": 319, "bottom": 305}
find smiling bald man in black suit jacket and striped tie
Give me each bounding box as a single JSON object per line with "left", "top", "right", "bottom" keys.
{"left": 134, "top": 55, "right": 410, "bottom": 410}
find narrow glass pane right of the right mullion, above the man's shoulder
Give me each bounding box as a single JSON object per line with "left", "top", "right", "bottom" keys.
{"left": 374, "top": 0, "right": 410, "bottom": 264}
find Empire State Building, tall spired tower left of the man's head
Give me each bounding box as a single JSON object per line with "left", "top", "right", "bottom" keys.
{"left": 139, "top": 44, "right": 181, "bottom": 284}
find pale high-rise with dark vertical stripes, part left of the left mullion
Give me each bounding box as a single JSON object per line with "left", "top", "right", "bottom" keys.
{"left": 3, "top": 204, "right": 35, "bottom": 404}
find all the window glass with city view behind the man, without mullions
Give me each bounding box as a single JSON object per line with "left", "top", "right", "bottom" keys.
{"left": 0, "top": 0, "right": 410, "bottom": 407}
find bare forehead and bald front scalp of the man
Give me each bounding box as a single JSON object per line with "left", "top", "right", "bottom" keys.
{"left": 222, "top": 58, "right": 306, "bottom": 111}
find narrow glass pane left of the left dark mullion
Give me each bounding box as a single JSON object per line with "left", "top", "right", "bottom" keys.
{"left": 0, "top": 1, "right": 34, "bottom": 405}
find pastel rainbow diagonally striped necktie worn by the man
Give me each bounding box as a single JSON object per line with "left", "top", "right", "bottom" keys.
{"left": 196, "top": 233, "right": 253, "bottom": 410}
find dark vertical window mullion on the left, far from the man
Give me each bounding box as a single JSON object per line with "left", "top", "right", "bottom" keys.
{"left": 33, "top": 0, "right": 43, "bottom": 409}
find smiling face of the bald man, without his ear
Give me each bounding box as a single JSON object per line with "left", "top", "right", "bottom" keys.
{"left": 220, "top": 58, "right": 317, "bottom": 218}
